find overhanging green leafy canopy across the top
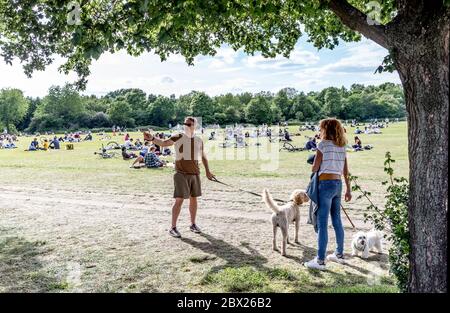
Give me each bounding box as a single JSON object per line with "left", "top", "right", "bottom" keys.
{"left": 0, "top": 0, "right": 395, "bottom": 88}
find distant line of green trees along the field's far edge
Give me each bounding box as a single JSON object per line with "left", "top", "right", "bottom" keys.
{"left": 0, "top": 83, "right": 406, "bottom": 132}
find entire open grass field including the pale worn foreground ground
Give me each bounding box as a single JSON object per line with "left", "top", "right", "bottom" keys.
{"left": 0, "top": 123, "right": 408, "bottom": 292}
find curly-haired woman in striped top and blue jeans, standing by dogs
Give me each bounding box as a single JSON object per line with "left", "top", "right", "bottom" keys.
{"left": 305, "top": 118, "right": 352, "bottom": 270}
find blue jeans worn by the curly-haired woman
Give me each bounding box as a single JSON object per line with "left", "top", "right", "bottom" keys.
{"left": 317, "top": 180, "right": 344, "bottom": 261}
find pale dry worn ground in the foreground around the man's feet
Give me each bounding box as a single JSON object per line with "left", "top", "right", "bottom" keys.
{"left": 0, "top": 177, "right": 387, "bottom": 292}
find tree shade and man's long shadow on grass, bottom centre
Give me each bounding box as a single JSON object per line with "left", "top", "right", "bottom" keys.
{"left": 181, "top": 234, "right": 392, "bottom": 292}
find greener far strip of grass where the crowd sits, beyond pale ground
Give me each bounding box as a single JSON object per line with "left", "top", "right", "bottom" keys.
{"left": 0, "top": 123, "right": 408, "bottom": 191}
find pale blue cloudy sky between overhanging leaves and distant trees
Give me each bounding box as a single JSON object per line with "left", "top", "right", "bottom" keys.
{"left": 0, "top": 37, "right": 400, "bottom": 96}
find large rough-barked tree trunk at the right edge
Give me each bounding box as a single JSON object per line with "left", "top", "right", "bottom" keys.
{"left": 390, "top": 8, "right": 449, "bottom": 292}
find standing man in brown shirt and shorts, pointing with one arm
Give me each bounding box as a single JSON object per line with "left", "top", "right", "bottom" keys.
{"left": 144, "top": 117, "right": 214, "bottom": 238}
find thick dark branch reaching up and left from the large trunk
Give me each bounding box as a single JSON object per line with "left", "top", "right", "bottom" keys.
{"left": 326, "top": 0, "right": 388, "bottom": 49}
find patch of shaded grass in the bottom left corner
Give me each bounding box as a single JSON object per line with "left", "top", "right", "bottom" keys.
{"left": 0, "top": 236, "right": 66, "bottom": 292}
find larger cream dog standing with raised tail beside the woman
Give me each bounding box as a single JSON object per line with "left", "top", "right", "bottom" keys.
{"left": 263, "top": 189, "right": 309, "bottom": 256}
